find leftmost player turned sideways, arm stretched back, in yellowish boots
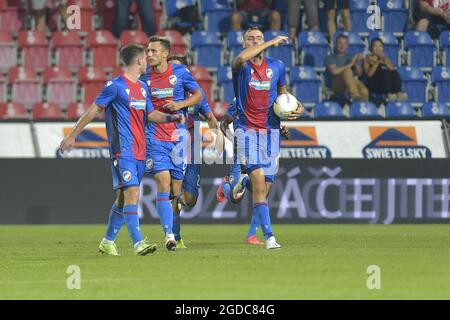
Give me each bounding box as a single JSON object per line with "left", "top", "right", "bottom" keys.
{"left": 60, "top": 44, "right": 184, "bottom": 256}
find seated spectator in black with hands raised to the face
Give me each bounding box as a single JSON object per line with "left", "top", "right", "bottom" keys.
{"left": 364, "top": 38, "right": 407, "bottom": 101}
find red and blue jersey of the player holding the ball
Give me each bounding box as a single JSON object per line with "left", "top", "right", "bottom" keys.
{"left": 233, "top": 57, "right": 286, "bottom": 130}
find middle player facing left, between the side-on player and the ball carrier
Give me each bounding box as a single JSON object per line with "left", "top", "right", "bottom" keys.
{"left": 141, "top": 36, "right": 202, "bottom": 250}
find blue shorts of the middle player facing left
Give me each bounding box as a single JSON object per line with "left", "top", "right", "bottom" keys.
{"left": 145, "top": 139, "right": 187, "bottom": 180}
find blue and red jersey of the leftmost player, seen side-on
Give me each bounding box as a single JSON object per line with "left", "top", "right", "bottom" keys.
{"left": 95, "top": 75, "right": 153, "bottom": 160}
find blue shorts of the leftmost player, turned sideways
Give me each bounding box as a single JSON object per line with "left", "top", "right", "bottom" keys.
{"left": 111, "top": 158, "right": 145, "bottom": 190}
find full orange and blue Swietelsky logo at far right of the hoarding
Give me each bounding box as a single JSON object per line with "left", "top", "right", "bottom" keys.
{"left": 363, "top": 126, "right": 431, "bottom": 159}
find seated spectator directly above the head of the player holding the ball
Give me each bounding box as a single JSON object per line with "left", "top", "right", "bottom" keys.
{"left": 231, "top": 0, "right": 281, "bottom": 31}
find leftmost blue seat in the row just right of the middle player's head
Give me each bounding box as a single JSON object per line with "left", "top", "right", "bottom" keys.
{"left": 191, "top": 31, "right": 222, "bottom": 69}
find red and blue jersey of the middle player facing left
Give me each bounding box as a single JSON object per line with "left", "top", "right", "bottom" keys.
{"left": 141, "top": 63, "right": 200, "bottom": 142}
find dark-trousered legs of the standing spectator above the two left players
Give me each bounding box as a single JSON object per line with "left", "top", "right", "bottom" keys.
{"left": 113, "top": 0, "right": 157, "bottom": 38}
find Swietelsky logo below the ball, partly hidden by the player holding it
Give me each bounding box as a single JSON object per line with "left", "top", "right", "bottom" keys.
{"left": 280, "top": 126, "right": 331, "bottom": 159}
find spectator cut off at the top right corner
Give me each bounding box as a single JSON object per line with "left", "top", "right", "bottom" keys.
{"left": 414, "top": 0, "right": 450, "bottom": 32}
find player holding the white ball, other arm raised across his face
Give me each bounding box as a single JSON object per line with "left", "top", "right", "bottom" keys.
{"left": 232, "top": 28, "right": 304, "bottom": 249}
